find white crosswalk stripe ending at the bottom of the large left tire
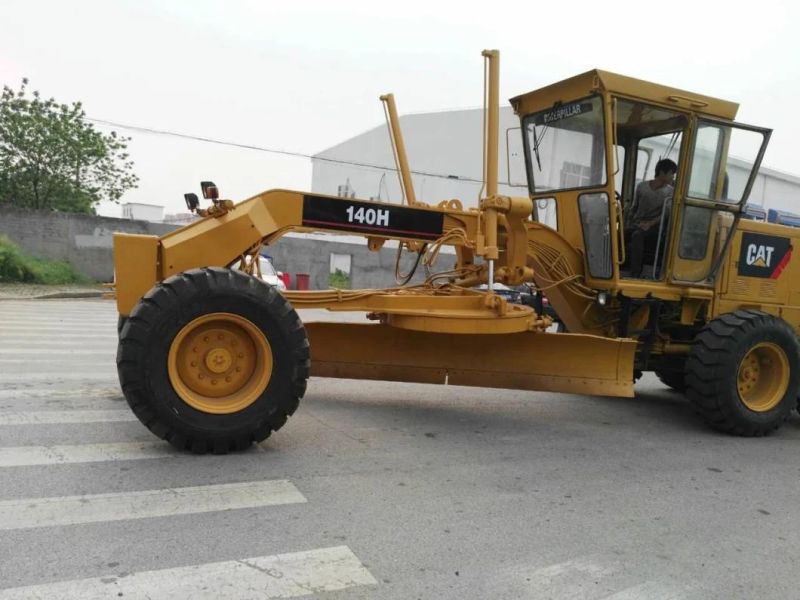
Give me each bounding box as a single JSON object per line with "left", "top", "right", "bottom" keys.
{"left": 0, "top": 442, "right": 183, "bottom": 468}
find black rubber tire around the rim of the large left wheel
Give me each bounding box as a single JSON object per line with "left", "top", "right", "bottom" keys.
{"left": 117, "top": 268, "right": 310, "bottom": 454}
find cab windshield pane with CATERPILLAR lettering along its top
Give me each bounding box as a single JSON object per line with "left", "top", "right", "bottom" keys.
{"left": 523, "top": 96, "right": 606, "bottom": 193}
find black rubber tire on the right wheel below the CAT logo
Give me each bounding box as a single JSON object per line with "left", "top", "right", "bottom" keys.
{"left": 686, "top": 310, "right": 800, "bottom": 437}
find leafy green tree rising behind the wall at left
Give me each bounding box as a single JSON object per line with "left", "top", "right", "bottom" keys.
{"left": 0, "top": 79, "right": 139, "bottom": 213}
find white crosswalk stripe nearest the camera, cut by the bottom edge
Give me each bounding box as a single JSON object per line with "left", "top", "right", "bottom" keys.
{"left": 0, "top": 546, "right": 378, "bottom": 600}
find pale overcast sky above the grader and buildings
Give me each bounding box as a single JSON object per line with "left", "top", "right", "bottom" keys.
{"left": 0, "top": 0, "right": 800, "bottom": 216}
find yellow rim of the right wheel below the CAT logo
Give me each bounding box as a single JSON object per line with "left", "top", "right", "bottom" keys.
{"left": 736, "top": 342, "right": 789, "bottom": 412}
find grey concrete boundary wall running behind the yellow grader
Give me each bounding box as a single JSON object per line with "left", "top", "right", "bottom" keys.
{"left": 0, "top": 208, "right": 432, "bottom": 289}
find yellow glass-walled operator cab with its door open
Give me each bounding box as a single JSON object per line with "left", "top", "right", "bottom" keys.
{"left": 511, "top": 71, "right": 770, "bottom": 294}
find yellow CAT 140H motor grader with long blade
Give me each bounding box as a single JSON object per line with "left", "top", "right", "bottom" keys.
{"left": 114, "top": 50, "right": 800, "bottom": 453}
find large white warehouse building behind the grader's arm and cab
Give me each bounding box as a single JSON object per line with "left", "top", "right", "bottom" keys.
{"left": 311, "top": 107, "right": 800, "bottom": 213}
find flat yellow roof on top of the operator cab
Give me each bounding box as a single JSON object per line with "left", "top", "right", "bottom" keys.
{"left": 510, "top": 69, "right": 739, "bottom": 121}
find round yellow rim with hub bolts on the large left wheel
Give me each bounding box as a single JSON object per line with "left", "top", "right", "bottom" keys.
{"left": 168, "top": 313, "right": 272, "bottom": 414}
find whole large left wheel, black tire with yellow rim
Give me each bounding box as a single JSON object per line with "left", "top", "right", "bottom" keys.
{"left": 117, "top": 268, "right": 309, "bottom": 453}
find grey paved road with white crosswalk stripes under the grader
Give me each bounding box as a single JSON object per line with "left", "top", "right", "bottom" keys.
{"left": 0, "top": 300, "right": 800, "bottom": 600}
